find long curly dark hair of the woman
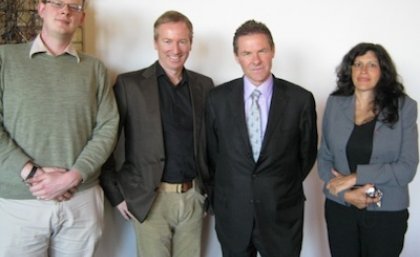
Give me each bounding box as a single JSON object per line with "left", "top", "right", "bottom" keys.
{"left": 331, "top": 43, "right": 406, "bottom": 126}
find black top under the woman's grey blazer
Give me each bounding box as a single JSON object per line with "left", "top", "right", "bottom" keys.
{"left": 346, "top": 118, "right": 376, "bottom": 173}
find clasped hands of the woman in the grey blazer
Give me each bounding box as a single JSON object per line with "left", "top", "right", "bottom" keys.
{"left": 326, "top": 169, "right": 381, "bottom": 209}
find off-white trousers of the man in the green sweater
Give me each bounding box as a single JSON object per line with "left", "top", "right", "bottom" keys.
{"left": 0, "top": 186, "right": 104, "bottom": 257}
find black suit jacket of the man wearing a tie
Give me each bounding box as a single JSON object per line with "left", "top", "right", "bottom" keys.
{"left": 206, "top": 74, "right": 318, "bottom": 250}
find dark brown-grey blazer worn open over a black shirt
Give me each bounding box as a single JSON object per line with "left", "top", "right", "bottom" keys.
{"left": 100, "top": 63, "right": 213, "bottom": 222}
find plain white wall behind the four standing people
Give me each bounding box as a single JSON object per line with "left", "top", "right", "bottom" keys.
{"left": 85, "top": 0, "right": 420, "bottom": 257}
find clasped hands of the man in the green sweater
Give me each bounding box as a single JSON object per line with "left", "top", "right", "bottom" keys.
{"left": 25, "top": 167, "right": 82, "bottom": 202}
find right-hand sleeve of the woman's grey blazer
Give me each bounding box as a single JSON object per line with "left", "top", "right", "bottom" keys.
{"left": 357, "top": 97, "right": 419, "bottom": 186}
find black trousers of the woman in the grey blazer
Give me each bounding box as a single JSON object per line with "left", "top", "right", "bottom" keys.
{"left": 325, "top": 199, "right": 409, "bottom": 257}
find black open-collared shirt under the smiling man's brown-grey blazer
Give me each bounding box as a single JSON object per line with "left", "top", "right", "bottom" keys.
{"left": 157, "top": 63, "right": 196, "bottom": 183}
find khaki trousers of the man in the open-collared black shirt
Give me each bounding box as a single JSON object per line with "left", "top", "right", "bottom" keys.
{"left": 134, "top": 188, "right": 204, "bottom": 257}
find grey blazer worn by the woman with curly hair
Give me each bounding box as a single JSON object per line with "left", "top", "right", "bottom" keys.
{"left": 318, "top": 96, "right": 419, "bottom": 211}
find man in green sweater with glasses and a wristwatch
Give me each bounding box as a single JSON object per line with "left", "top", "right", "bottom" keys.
{"left": 0, "top": 0, "right": 119, "bottom": 257}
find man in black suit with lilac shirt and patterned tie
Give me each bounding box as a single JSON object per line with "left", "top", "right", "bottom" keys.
{"left": 206, "top": 20, "right": 318, "bottom": 257}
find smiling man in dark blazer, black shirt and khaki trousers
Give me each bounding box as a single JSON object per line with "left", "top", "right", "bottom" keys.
{"left": 101, "top": 11, "right": 213, "bottom": 257}
